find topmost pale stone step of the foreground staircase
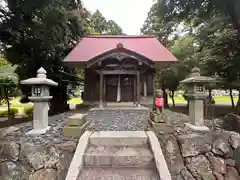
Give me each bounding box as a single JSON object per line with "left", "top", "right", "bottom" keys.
{"left": 89, "top": 131, "right": 148, "bottom": 147}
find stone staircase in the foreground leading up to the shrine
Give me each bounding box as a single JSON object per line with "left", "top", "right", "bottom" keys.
{"left": 66, "top": 131, "right": 171, "bottom": 180}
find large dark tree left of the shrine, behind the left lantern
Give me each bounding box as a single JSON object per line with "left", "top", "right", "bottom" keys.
{"left": 0, "top": 0, "right": 87, "bottom": 112}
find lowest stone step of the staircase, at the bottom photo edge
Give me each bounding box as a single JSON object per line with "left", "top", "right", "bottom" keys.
{"left": 77, "top": 167, "right": 160, "bottom": 180}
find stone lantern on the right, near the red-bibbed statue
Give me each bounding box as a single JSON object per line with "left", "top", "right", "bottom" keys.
{"left": 181, "top": 67, "right": 216, "bottom": 131}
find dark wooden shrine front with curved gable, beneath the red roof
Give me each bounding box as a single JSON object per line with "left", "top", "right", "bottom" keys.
{"left": 83, "top": 44, "right": 155, "bottom": 107}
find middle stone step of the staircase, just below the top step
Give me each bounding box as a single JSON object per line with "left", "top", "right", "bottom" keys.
{"left": 84, "top": 146, "right": 154, "bottom": 167}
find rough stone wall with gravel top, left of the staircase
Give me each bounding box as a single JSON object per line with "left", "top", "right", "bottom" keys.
{"left": 0, "top": 113, "right": 78, "bottom": 180}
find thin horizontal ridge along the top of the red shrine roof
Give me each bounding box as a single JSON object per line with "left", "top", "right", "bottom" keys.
{"left": 84, "top": 34, "right": 156, "bottom": 38}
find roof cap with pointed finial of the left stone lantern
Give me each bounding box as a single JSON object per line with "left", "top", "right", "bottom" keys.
{"left": 20, "top": 67, "right": 58, "bottom": 86}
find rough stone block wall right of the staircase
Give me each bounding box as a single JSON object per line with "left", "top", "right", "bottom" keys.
{"left": 158, "top": 131, "right": 240, "bottom": 180}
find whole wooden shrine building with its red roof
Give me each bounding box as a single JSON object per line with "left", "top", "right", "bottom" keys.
{"left": 63, "top": 35, "right": 177, "bottom": 108}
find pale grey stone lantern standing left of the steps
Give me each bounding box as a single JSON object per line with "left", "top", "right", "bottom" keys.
{"left": 21, "top": 67, "right": 58, "bottom": 135}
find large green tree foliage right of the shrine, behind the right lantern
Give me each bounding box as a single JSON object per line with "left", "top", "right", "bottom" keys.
{"left": 141, "top": 0, "right": 240, "bottom": 106}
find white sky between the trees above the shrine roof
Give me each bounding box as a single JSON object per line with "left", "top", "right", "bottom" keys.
{"left": 82, "top": 0, "right": 153, "bottom": 35}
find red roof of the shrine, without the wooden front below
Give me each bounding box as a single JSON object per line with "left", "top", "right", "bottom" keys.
{"left": 63, "top": 35, "right": 177, "bottom": 62}
